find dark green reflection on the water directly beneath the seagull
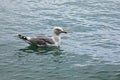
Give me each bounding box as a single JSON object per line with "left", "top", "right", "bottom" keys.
{"left": 19, "top": 45, "right": 63, "bottom": 56}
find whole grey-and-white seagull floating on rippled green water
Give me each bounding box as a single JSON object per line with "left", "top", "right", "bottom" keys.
{"left": 17, "top": 27, "right": 67, "bottom": 47}
